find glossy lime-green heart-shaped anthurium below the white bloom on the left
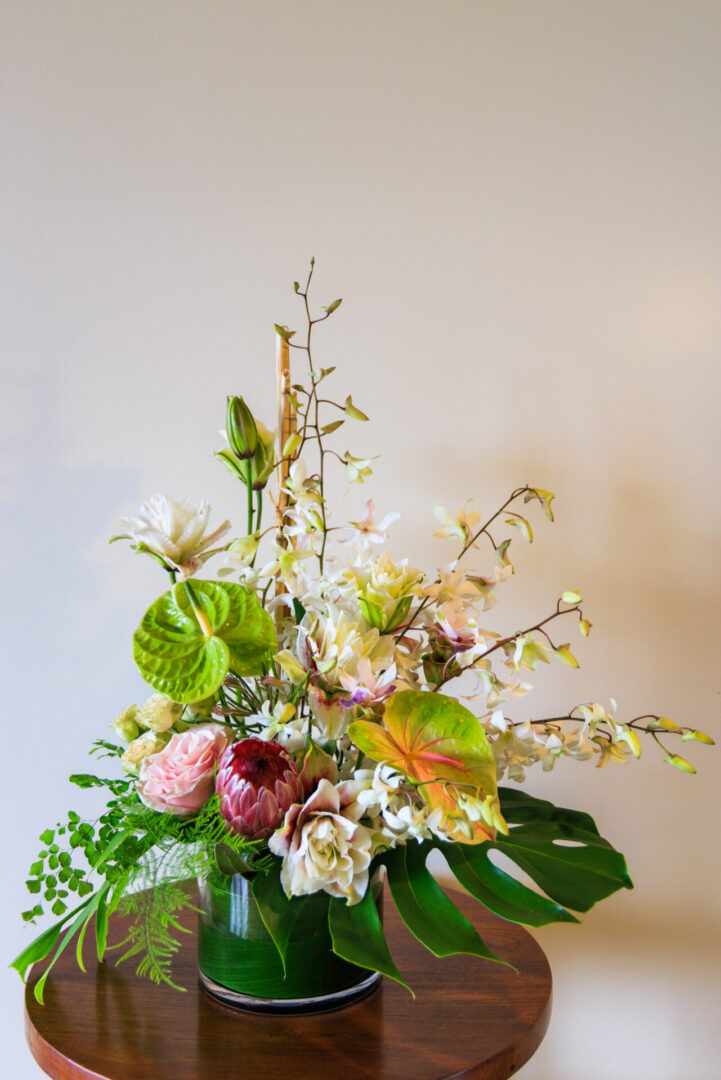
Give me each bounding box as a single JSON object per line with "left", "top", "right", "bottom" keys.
{"left": 133, "top": 581, "right": 276, "bottom": 702}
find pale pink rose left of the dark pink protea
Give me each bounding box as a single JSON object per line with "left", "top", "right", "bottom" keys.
{"left": 136, "top": 724, "right": 230, "bottom": 818}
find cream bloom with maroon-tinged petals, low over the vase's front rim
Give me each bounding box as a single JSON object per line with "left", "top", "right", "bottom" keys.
{"left": 268, "top": 779, "right": 371, "bottom": 904}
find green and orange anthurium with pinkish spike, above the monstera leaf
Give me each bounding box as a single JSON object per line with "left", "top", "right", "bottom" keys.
{"left": 349, "top": 690, "right": 504, "bottom": 843}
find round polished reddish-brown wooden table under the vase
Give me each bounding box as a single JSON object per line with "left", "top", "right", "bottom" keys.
{"left": 26, "top": 893, "right": 552, "bottom": 1080}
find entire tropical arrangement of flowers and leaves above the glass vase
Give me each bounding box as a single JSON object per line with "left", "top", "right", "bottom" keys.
{"left": 13, "top": 264, "right": 712, "bottom": 1000}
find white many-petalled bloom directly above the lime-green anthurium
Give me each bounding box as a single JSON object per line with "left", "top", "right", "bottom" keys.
{"left": 110, "top": 495, "right": 230, "bottom": 578}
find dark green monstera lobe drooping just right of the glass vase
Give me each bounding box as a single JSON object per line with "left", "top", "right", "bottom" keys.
{"left": 381, "top": 843, "right": 505, "bottom": 963}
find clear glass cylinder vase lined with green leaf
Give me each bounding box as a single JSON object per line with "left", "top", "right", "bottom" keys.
{"left": 198, "top": 870, "right": 382, "bottom": 1013}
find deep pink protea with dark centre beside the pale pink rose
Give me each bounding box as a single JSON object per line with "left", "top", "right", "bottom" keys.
{"left": 215, "top": 738, "right": 305, "bottom": 840}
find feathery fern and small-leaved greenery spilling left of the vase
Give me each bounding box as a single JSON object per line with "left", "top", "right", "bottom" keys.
{"left": 13, "top": 740, "right": 275, "bottom": 1000}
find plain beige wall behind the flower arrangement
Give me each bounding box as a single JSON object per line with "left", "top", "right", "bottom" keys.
{"left": 0, "top": 0, "right": 721, "bottom": 1080}
